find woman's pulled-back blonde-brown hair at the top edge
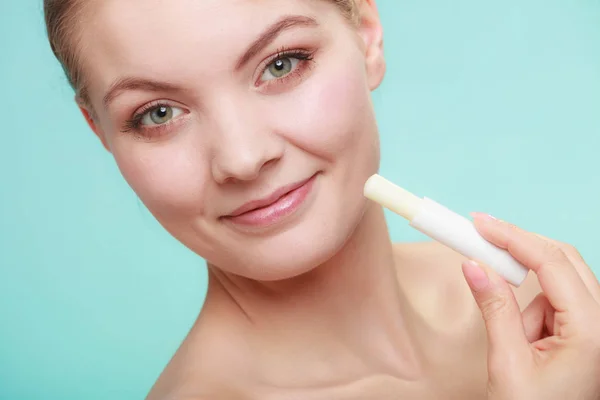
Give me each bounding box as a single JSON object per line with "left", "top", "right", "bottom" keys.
{"left": 44, "top": 0, "right": 357, "bottom": 102}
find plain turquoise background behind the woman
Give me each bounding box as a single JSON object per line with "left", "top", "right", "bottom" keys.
{"left": 0, "top": 0, "right": 600, "bottom": 400}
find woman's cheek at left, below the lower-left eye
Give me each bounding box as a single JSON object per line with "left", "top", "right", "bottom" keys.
{"left": 113, "top": 138, "right": 208, "bottom": 218}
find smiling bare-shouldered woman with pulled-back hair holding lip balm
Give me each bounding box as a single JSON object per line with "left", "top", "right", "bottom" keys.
{"left": 45, "top": 0, "right": 600, "bottom": 400}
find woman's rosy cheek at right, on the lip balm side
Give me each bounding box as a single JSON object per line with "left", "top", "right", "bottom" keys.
{"left": 268, "top": 63, "right": 373, "bottom": 160}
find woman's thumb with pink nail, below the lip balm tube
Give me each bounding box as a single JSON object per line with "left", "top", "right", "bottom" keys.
{"left": 463, "top": 261, "right": 531, "bottom": 374}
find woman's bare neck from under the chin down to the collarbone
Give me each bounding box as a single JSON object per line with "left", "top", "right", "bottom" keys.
{"left": 200, "top": 205, "right": 418, "bottom": 382}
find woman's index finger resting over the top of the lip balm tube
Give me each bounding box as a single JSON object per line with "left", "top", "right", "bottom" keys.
{"left": 474, "top": 214, "right": 593, "bottom": 312}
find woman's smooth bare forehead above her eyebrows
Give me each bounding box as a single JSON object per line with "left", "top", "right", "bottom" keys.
{"left": 80, "top": 0, "right": 341, "bottom": 98}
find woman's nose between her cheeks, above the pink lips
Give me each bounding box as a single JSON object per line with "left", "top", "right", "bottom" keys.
{"left": 211, "top": 97, "right": 284, "bottom": 184}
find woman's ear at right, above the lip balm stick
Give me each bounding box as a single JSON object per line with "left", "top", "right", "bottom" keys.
{"left": 357, "top": 0, "right": 386, "bottom": 90}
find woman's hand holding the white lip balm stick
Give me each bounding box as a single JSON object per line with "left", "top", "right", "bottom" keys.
{"left": 463, "top": 214, "right": 600, "bottom": 400}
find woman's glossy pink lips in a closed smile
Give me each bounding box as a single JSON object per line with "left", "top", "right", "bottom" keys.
{"left": 224, "top": 175, "right": 316, "bottom": 227}
